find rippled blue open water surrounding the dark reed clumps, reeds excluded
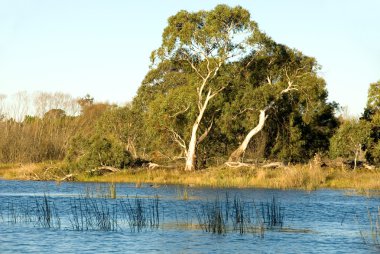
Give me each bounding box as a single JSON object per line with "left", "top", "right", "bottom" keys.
{"left": 0, "top": 180, "right": 380, "bottom": 253}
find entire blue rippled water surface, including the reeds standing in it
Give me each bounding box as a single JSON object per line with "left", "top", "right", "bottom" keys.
{"left": 0, "top": 181, "right": 380, "bottom": 253}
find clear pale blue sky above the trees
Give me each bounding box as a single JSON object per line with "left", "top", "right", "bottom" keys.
{"left": 0, "top": 0, "right": 380, "bottom": 115}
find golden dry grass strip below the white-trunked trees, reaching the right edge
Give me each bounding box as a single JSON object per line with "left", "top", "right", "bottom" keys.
{"left": 78, "top": 165, "right": 380, "bottom": 191}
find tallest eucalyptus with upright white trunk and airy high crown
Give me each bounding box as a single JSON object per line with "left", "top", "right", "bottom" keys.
{"left": 152, "top": 5, "right": 264, "bottom": 170}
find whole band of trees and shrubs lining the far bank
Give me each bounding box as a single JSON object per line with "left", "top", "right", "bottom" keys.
{"left": 0, "top": 5, "right": 380, "bottom": 170}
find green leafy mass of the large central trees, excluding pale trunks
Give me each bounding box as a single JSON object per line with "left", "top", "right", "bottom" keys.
{"left": 132, "top": 5, "right": 338, "bottom": 165}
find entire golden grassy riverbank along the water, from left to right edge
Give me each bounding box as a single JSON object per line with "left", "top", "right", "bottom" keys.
{"left": 0, "top": 163, "right": 380, "bottom": 192}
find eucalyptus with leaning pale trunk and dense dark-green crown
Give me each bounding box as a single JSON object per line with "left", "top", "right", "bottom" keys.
{"left": 224, "top": 43, "right": 337, "bottom": 162}
